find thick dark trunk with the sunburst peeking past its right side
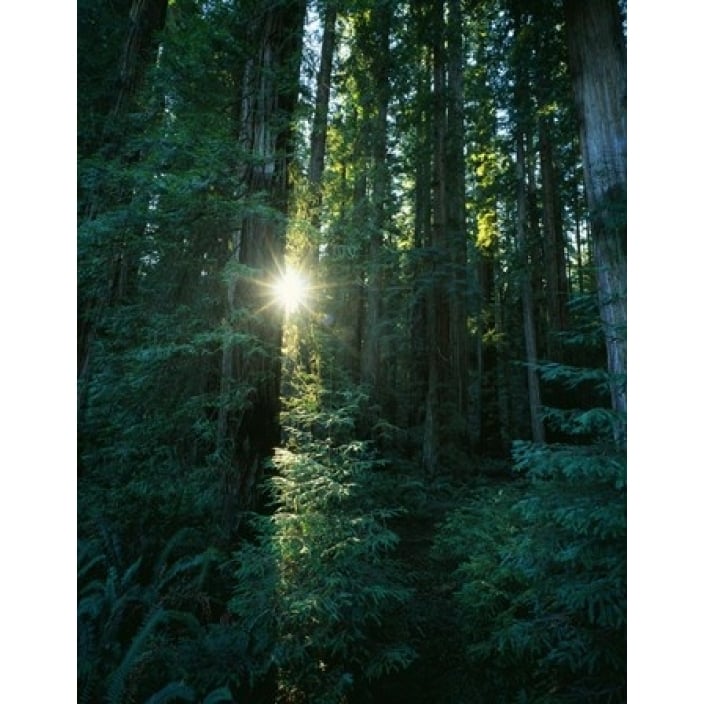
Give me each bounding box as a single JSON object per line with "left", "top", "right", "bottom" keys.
{"left": 223, "top": 0, "right": 305, "bottom": 533}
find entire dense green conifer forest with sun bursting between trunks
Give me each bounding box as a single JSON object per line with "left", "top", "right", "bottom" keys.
{"left": 76, "top": 0, "right": 627, "bottom": 704}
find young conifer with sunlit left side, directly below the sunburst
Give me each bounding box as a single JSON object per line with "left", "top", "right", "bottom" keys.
{"left": 230, "top": 382, "right": 414, "bottom": 703}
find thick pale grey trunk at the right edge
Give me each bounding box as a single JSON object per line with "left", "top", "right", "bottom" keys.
{"left": 565, "top": 0, "right": 626, "bottom": 443}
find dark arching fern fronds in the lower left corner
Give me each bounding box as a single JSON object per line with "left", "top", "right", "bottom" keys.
{"left": 77, "top": 531, "right": 238, "bottom": 704}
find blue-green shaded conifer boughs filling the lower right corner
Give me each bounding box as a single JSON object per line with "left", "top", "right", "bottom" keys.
{"left": 435, "top": 350, "right": 626, "bottom": 702}
